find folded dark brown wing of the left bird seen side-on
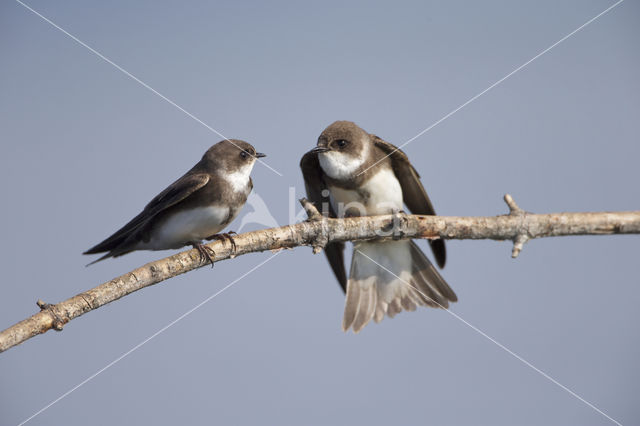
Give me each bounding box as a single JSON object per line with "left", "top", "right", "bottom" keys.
{"left": 84, "top": 173, "right": 210, "bottom": 255}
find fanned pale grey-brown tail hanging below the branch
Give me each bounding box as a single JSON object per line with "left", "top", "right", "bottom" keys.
{"left": 342, "top": 240, "right": 458, "bottom": 333}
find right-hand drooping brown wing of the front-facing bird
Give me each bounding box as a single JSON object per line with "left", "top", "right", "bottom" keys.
{"left": 371, "top": 135, "right": 447, "bottom": 268}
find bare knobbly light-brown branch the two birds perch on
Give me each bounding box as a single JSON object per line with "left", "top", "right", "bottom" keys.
{"left": 0, "top": 194, "right": 640, "bottom": 352}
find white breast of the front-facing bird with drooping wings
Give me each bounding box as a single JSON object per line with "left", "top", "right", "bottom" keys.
{"left": 329, "top": 168, "right": 402, "bottom": 216}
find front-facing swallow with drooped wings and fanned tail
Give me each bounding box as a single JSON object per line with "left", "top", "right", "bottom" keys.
{"left": 300, "top": 121, "right": 458, "bottom": 333}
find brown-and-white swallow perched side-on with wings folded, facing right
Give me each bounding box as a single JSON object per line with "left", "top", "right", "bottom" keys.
{"left": 83, "top": 139, "right": 266, "bottom": 266}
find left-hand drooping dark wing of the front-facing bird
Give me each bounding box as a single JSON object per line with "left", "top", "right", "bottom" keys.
{"left": 300, "top": 152, "right": 347, "bottom": 291}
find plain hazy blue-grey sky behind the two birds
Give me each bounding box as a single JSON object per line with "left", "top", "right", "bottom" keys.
{"left": 0, "top": 0, "right": 640, "bottom": 425}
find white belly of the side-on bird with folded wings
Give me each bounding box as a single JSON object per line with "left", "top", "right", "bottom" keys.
{"left": 137, "top": 206, "right": 229, "bottom": 250}
